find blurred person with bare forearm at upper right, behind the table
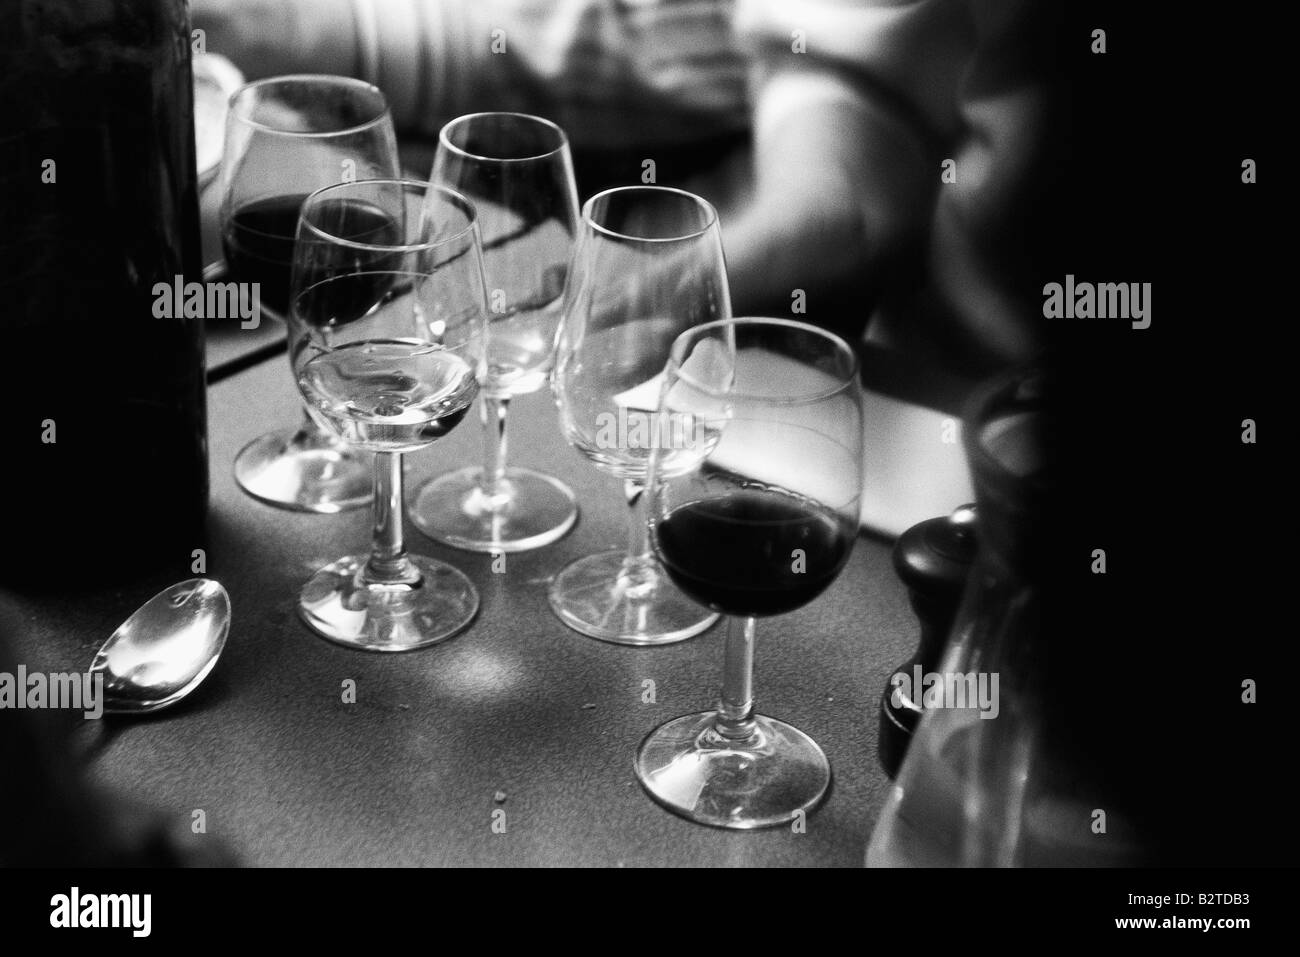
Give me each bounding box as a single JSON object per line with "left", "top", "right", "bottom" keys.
{"left": 723, "top": 0, "right": 1065, "bottom": 377}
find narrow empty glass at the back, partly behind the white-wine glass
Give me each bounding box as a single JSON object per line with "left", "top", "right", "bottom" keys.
{"left": 411, "top": 113, "right": 579, "bottom": 553}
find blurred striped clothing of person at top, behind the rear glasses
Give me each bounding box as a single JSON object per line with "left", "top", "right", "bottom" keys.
{"left": 191, "top": 0, "right": 748, "bottom": 159}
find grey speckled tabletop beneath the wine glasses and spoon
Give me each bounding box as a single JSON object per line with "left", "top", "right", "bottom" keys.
{"left": 0, "top": 356, "right": 917, "bottom": 866}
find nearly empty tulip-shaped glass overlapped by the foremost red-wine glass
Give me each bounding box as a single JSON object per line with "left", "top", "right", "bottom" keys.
{"left": 549, "top": 186, "right": 731, "bottom": 645}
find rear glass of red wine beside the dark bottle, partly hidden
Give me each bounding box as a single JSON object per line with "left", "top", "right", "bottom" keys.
{"left": 220, "top": 75, "right": 398, "bottom": 512}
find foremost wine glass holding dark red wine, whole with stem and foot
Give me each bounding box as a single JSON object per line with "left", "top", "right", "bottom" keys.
{"left": 636, "top": 319, "right": 863, "bottom": 828}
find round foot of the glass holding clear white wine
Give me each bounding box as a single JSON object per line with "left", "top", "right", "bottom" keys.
{"left": 298, "top": 555, "right": 478, "bottom": 651}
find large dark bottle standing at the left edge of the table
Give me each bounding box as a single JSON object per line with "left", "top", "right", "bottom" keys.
{"left": 0, "top": 0, "right": 208, "bottom": 586}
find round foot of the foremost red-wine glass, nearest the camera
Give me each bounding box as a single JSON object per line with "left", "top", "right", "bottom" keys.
{"left": 636, "top": 711, "right": 831, "bottom": 831}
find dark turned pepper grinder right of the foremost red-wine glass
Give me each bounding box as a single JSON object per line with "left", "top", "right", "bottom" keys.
{"left": 878, "top": 505, "right": 976, "bottom": 778}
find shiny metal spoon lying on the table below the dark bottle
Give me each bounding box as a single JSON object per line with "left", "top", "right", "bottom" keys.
{"left": 90, "top": 579, "right": 230, "bottom": 714}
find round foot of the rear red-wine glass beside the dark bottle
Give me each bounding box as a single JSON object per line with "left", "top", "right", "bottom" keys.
{"left": 235, "top": 429, "right": 374, "bottom": 514}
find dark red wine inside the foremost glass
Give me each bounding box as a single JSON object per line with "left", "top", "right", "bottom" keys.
{"left": 654, "top": 489, "right": 857, "bottom": 618}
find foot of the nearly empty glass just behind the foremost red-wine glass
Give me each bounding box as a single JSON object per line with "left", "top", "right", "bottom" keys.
{"left": 547, "top": 551, "right": 719, "bottom": 645}
